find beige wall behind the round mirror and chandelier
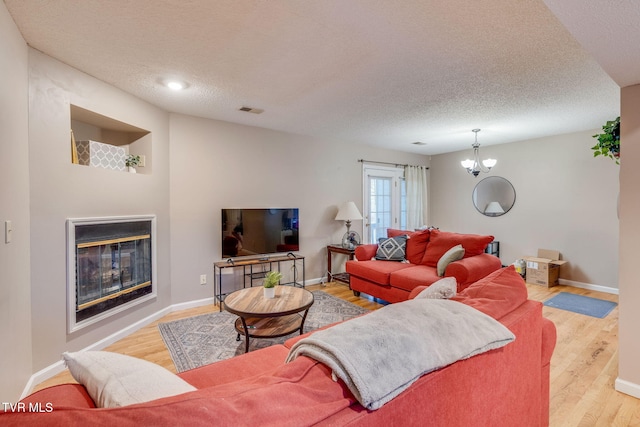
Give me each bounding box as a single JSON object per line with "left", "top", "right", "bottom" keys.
{"left": 430, "top": 130, "right": 619, "bottom": 291}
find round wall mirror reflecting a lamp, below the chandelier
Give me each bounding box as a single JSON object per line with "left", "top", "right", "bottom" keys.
{"left": 472, "top": 176, "right": 516, "bottom": 216}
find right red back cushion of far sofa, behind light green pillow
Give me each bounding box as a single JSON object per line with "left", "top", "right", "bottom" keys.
{"left": 420, "top": 230, "right": 494, "bottom": 267}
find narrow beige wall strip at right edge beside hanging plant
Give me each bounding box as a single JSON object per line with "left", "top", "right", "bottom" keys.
{"left": 616, "top": 85, "right": 640, "bottom": 398}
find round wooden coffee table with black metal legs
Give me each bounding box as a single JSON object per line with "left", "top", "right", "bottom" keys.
{"left": 224, "top": 285, "right": 313, "bottom": 353}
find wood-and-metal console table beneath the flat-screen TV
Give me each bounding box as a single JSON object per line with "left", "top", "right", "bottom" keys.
{"left": 213, "top": 253, "right": 305, "bottom": 310}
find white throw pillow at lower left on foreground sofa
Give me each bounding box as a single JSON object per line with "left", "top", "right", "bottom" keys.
{"left": 62, "top": 351, "right": 197, "bottom": 408}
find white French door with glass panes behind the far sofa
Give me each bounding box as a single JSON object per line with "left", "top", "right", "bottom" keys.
{"left": 362, "top": 164, "right": 407, "bottom": 243}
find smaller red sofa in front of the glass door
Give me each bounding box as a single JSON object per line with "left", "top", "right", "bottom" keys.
{"left": 346, "top": 229, "right": 502, "bottom": 303}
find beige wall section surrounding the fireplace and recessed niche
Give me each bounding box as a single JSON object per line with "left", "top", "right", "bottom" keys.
{"left": 24, "top": 49, "right": 171, "bottom": 372}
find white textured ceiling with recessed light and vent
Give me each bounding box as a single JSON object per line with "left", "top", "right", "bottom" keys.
{"left": 5, "top": 0, "right": 624, "bottom": 154}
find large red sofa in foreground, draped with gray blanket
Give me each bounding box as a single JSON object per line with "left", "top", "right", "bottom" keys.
{"left": 0, "top": 267, "right": 556, "bottom": 427}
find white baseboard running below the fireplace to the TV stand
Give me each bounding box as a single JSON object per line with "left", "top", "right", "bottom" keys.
{"left": 20, "top": 297, "right": 215, "bottom": 399}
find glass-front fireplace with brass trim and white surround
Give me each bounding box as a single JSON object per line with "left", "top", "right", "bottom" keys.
{"left": 67, "top": 216, "right": 155, "bottom": 332}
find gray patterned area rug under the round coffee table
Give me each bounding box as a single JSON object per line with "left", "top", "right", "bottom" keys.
{"left": 158, "top": 291, "right": 369, "bottom": 372}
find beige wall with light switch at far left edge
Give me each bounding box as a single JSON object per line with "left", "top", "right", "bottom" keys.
{"left": 0, "top": 3, "right": 32, "bottom": 402}
